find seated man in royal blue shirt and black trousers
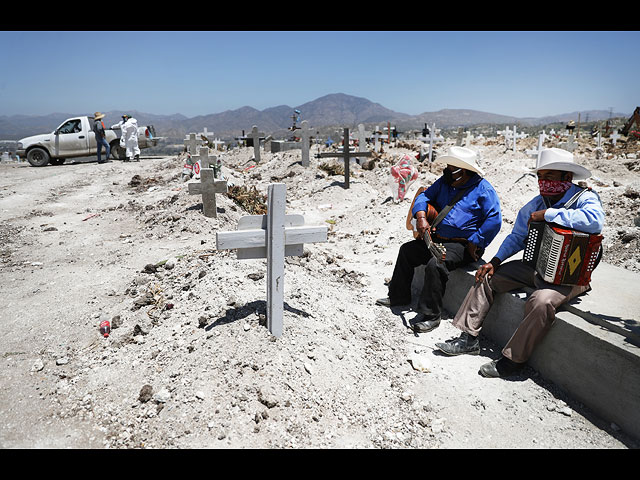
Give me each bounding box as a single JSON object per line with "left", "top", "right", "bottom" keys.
{"left": 376, "top": 147, "right": 502, "bottom": 333}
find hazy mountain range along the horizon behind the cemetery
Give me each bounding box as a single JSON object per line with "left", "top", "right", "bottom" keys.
{"left": 0, "top": 93, "right": 630, "bottom": 142}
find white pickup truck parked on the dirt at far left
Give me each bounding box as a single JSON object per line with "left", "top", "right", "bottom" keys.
{"left": 16, "top": 116, "right": 158, "bottom": 167}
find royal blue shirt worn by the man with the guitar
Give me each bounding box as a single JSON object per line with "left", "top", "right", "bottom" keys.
{"left": 411, "top": 174, "right": 502, "bottom": 248}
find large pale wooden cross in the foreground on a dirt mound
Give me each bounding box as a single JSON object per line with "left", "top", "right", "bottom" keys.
{"left": 216, "top": 183, "right": 327, "bottom": 337}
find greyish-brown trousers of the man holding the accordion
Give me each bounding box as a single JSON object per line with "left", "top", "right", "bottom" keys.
{"left": 453, "top": 260, "right": 589, "bottom": 363}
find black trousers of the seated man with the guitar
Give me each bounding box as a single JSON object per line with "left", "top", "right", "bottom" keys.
{"left": 389, "top": 239, "right": 482, "bottom": 320}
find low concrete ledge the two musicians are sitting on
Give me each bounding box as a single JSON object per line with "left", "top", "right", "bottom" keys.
{"left": 412, "top": 255, "right": 640, "bottom": 439}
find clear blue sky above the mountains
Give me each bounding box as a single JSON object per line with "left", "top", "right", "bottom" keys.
{"left": 0, "top": 30, "right": 640, "bottom": 117}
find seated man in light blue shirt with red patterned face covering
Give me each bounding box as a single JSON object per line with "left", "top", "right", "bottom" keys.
{"left": 436, "top": 148, "right": 604, "bottom": 377}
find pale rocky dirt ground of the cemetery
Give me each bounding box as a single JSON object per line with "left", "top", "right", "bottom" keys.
{"left": 0, "top": 133, "right": 640, "bottom": 449}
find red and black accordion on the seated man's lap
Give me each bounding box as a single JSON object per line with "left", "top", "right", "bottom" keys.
{"left": 522, "top": 222, "right": 603, "bottom": 285}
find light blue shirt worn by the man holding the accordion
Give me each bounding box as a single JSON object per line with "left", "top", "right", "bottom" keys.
{"left": 496, "top": 184, "right": 604, "bottom": 261}
